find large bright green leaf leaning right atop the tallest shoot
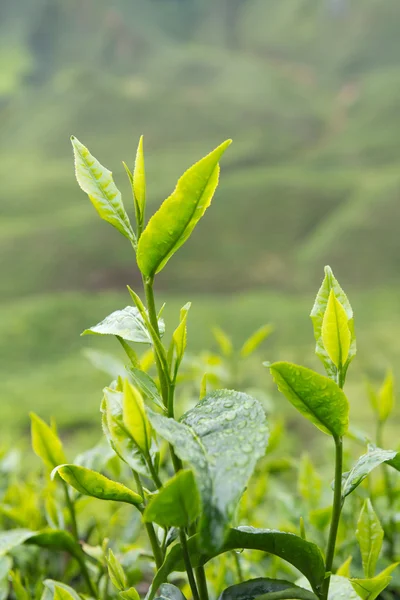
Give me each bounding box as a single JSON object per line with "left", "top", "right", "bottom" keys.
{"left": 137, "top": 140, "right": 231, "bottom": 277}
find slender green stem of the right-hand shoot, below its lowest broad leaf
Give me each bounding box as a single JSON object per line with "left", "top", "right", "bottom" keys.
{"left": 321, "top": 437, "right": 343, "bottom": 600}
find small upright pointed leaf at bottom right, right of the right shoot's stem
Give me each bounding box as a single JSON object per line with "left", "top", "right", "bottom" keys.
{"left": 356, "top": 499, "right": 384, "bottom": 578}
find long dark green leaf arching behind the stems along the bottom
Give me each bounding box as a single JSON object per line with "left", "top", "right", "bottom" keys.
{"left": 147, "top": 527, "right": 325, "bottom": 600}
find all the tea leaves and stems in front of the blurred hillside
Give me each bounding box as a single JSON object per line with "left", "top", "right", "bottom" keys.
{"left": 0, "top": 138, "right": 400, "bottom": 600}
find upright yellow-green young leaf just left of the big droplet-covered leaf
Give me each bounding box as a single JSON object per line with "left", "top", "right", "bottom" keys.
{"left": 123, "top": 380, "right": 152, "bottom": 455}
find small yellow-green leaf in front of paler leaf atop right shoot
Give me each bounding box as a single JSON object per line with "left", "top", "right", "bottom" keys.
{"left": 321, "top": 289, "right": 351, "bottom": 369}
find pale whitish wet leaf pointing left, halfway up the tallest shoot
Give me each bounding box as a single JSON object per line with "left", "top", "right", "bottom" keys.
{"left": 81, "top": 306, "right": 165, "bottom": 344}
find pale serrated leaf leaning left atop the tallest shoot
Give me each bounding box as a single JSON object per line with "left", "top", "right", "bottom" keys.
{"left": 71, "top": 136, "right": 136, "bottom": 244}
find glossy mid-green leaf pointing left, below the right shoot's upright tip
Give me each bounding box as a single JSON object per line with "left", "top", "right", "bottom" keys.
{"left": 268, "top": 362, "right": 349, "bottom": 437}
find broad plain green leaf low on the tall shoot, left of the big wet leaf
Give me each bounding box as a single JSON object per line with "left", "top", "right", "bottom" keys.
{"left": 143, "top": 469, "right": 200, "bottom": 527}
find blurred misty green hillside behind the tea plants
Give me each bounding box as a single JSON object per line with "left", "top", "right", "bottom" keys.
{"left": 0, "top": 0, "right": 400, "bottom": 448}
